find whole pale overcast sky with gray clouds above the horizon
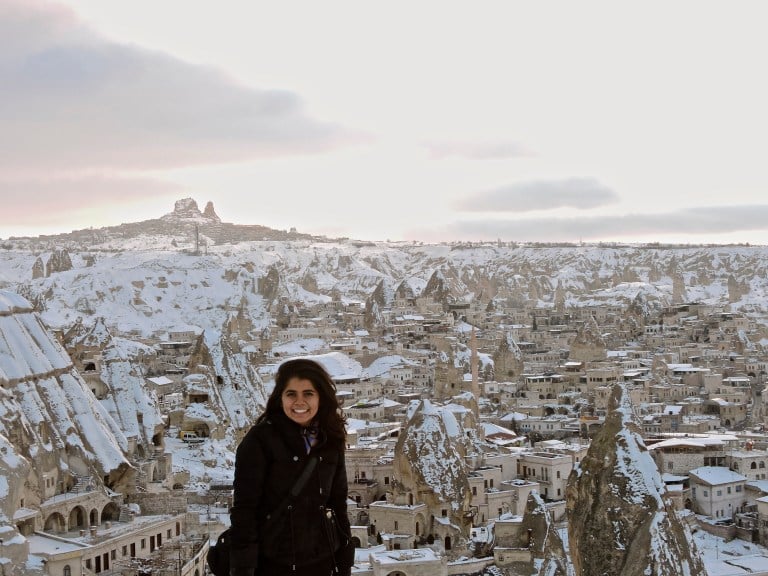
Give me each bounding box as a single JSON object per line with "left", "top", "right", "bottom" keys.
{"left": 0, "top": 0, "right": 768, "bottom": 244}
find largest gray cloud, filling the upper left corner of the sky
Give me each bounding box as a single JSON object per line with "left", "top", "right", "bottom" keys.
{"left": 0, "top": 3, "right": 352, "bottom": 169}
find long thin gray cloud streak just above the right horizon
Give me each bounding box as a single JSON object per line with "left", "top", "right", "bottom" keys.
{"left": 412, "top": 204, "right": 768, "bottom": 242}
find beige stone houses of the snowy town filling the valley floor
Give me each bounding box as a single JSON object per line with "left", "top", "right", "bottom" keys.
{"left": 7, "top": 288, "right": 768, "bottom": 576}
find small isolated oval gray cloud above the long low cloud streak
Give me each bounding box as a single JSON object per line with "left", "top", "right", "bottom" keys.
{"left": 457, "top": 178, "right": 619, "bottom": 212}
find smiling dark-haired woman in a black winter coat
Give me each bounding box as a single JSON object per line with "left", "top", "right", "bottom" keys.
{"left": 230, "top": 358, "right": 354, "bottom": 576}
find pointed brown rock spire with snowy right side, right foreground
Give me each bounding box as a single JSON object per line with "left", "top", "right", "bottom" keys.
{"left": 566, "top": 385, "right": 705, "bottom": 576}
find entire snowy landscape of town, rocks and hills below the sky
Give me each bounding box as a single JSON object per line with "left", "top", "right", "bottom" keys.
{"left": 0, "top": 199, "right": 768, "bottom": 576}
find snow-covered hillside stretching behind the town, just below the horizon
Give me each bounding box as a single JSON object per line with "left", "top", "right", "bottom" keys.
{"left": 0, "top": 239, "right": 768, "bottom": 336}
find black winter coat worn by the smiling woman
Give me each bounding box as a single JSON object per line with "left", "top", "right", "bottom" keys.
{"left": 230, "top": 414, "right": 354, "bottom": 575}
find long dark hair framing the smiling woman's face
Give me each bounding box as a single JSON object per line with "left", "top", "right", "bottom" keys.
{"left": 256, "top": 358, "right": 347, "bottom": 443}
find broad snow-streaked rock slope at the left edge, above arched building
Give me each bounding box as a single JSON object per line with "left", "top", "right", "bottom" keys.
{"left": 0, "top": 290, "right": 135, "bottom": 532}
